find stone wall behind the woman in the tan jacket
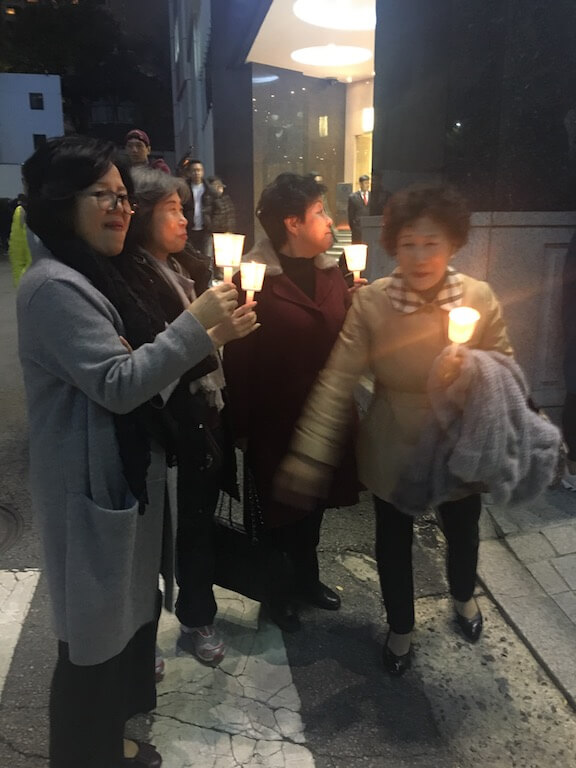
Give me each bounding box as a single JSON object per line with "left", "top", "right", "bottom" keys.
{"left": 362, "top": 212, "right": 576, "bottom": 407}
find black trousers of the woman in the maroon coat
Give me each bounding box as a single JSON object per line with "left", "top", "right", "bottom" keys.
{"left": 260, "top": 511, "right": 324, "bottom": 601}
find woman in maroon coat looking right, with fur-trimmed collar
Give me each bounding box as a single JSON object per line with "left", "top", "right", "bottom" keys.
{"left": 224, "top": 173, "right": 357, "bottom": 631}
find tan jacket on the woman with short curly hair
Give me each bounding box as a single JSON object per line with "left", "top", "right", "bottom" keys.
{"left": 291, "top": 275, "right": 512, "bottom": 501}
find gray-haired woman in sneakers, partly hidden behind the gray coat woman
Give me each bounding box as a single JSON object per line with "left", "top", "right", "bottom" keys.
{"left": 119, "top": 168, "right": 258, "bottom": 669}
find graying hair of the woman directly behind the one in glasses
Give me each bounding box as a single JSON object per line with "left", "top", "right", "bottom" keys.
{"left": 124, "top": 167, "right": 190, "bottom": 251}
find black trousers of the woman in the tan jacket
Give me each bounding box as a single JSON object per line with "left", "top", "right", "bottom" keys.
{"left": 374, "top": 494, "right": 482, "bottom": 634}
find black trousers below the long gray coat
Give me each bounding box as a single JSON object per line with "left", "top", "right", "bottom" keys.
{"left": 50, "top": 616, "right": 160, "bottom": 768}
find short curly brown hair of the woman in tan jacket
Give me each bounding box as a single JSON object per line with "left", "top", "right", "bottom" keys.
{"left": 382, "top": 184, "right": 470, "bottom": 256}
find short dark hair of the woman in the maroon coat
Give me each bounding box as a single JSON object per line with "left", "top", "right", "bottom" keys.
{"left": 256, "top": 173, "right": 326, "bottom": 250}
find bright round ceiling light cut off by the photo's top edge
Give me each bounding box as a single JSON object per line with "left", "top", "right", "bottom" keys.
{"left": 292, "top": 0, "right": 376, "bottom": 32}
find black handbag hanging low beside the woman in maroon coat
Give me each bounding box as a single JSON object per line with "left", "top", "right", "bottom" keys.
{"left": 214, "top": 462, "right": 289, "bottom": 603}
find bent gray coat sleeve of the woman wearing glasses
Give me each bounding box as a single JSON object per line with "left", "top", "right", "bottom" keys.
{"left": 18, "top": 279, "right": 214, "bottom": 413}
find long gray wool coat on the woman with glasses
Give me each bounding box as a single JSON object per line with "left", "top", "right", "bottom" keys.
{"left": 17, "top": 244, "right": 214, "bottom": 665}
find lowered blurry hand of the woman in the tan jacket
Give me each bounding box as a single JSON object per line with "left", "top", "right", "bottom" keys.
{"left": 274, "top": 453, "right": 332, "bottom": 510}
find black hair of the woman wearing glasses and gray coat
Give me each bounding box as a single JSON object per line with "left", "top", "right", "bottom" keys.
{"left": 22, "top": 136, "right": 132, "bottom": 240}
